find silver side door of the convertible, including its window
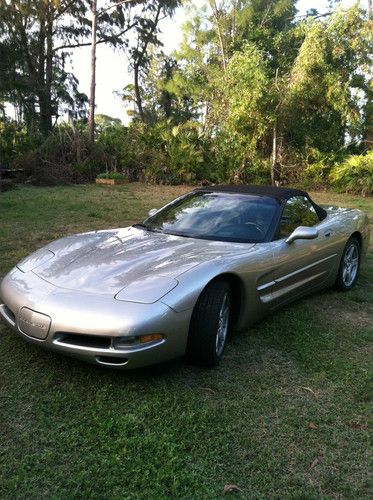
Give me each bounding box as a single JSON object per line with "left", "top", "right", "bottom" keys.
{"left": 270, "top": 196, "right": 337, "bottom": 307}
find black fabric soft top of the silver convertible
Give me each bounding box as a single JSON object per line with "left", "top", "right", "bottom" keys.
{"left": 195, "top": 184, "right": 327, "bottom": 220}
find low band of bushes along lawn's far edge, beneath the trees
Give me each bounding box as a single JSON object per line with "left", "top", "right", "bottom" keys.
{"left": 13, "top": 120, "right": 373, "bottom": 191}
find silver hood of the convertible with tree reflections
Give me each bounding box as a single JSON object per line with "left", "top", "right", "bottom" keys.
{"left": 29, "top": 227, "right": 253, "bottom": 296}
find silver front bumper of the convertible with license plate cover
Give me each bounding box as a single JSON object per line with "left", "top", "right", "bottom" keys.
{"left": 0, "top": 268, "right": 192, "bottom": 369}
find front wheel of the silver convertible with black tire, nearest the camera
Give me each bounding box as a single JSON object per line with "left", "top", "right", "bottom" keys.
{"left": 187, "top": 281, "right": 231, "bottom": 367}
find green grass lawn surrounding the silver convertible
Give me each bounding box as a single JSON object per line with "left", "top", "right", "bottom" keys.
{"left": 0, "top": 184, "right": 373, "bottom": 499}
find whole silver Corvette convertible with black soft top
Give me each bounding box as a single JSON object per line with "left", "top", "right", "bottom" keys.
{"left": 0, "top": 186, "right": 369, "bottom": 368}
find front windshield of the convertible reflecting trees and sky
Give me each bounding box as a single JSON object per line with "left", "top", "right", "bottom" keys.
{"left": 137, "top": 191, "right": 279, "bottom": 243}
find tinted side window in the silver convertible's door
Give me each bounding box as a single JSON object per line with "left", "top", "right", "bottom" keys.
{"left": 279, "top": 196, "right": 319, "bottom": 238}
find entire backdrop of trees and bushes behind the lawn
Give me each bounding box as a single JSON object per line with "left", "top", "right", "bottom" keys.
{"left": 0, "top": 0, "right": 373, "bottom": 194}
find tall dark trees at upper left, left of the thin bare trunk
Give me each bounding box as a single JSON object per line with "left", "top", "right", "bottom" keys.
{"left": 0, "top": 0, "right": 89, "bottom": 137}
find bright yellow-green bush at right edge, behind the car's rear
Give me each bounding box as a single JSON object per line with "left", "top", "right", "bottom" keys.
{"left": 329, "top": 151, "right": 373, "bottom": 196}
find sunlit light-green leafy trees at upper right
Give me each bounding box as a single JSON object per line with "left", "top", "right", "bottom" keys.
{"left": 166, "top": 0, "right": 373, "bottom": 183}
